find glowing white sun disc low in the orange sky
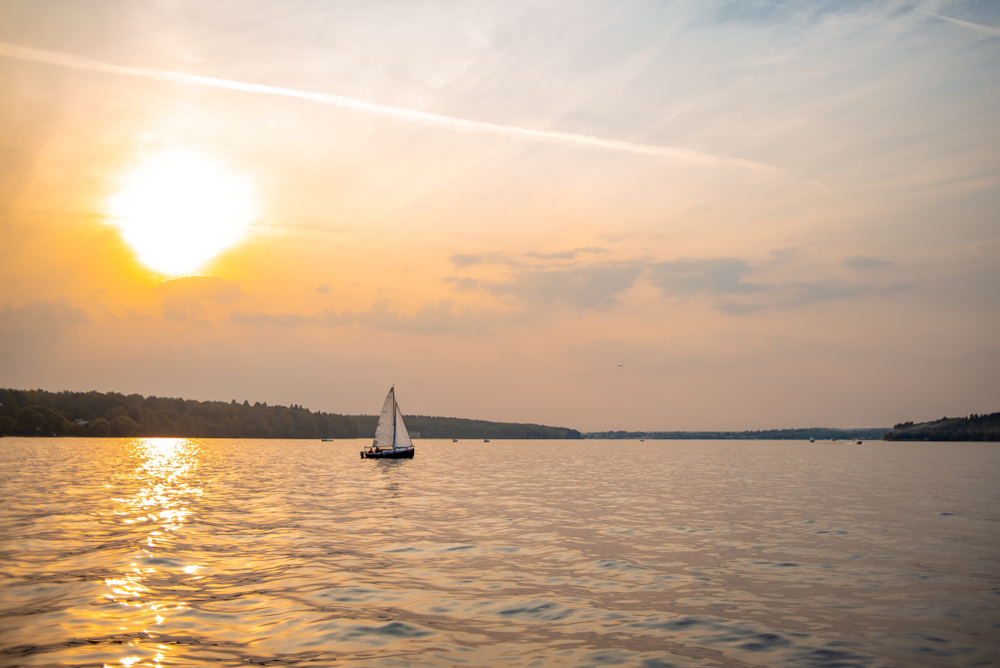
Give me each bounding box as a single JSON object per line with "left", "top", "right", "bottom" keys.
{"left": 108, "top": 152, "right": 256, "bottom": 276}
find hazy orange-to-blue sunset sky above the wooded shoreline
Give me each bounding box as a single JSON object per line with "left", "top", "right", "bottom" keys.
{"left": 0, "top": 0, "right": 1000, "bottom": 430}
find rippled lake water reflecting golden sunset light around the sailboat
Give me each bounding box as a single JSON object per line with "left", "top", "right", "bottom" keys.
{"left": 0, "top": 437, "right": 1000, "bottom": 668}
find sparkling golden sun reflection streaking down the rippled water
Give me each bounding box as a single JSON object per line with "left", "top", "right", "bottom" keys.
{"left": 104, "top": 438, "right": 202, "bottom": 668}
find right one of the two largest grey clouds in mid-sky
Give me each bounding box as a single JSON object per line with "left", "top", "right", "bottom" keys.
{"left": 647, "top": 257, "right": 771, "bottom": 297}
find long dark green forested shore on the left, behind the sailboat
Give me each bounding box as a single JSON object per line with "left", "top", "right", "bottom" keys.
{"left": 0, "top": 388, "right": 580, "bottom": 439}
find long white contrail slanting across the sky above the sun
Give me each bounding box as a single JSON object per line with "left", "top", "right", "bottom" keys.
{"left": 0, "top": 42, "right": 784, "bottom": 174}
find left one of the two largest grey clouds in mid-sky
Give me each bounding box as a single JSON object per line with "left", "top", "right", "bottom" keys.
{"left": 483, "top": 262, "right": 643, "bottom": 309}
